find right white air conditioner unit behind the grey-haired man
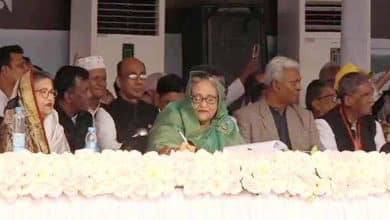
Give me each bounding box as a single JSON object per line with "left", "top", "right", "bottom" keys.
{"left": 277, "top": 0, "right": 342, "bottom": 104}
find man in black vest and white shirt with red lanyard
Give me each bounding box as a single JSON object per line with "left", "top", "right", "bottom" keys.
{"left": 316, "top": 72, "right": 385, "bottom": 151}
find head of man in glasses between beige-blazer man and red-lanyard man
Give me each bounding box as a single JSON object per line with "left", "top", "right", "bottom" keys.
{"left": 306, "top": 79, "right": 337, "bottom": 118}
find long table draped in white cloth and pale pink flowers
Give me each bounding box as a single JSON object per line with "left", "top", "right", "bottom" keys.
{"left": 0, "top": 151, "right": 390, "bottom": 220}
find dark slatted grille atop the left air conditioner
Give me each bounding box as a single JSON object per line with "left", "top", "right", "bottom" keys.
{"left": 98, "top": 0, "right": 159, "bottom": 35}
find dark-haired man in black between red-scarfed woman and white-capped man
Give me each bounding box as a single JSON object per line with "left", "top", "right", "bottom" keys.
{"left": 54, "top": 66, "right": 93, "bottom": 152}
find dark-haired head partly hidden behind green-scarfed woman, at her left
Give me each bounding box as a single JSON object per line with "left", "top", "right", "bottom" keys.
{"left": 156, "top": 74, "right": 184, "bottom": 111}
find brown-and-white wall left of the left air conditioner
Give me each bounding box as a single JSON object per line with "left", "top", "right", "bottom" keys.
{"left": 0, "top": 0, "right": 70, "bottom": 73}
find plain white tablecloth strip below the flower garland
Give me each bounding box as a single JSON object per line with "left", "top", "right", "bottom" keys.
{"left": 0, "top": 190, "right": 390, "bottom": 220}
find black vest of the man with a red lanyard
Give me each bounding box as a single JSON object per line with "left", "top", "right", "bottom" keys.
{"left": 322, "top": 107, "right": 376, "bottom": 151}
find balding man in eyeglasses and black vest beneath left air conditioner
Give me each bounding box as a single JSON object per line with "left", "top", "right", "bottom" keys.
{"left": 107, "top": 58, "right": 158, "bottom": 152}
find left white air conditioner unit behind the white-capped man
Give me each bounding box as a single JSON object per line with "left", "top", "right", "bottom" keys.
{"left": 70, "top": 0, "right": 165, "bottom": 89}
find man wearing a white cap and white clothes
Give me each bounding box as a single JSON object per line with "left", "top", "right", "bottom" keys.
{"left": 76, "top": 56, "right": 121, "bottom": 150}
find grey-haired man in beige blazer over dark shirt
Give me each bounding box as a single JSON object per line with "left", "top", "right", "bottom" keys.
{"left": 235, "top": 56, "right": 321, "bottom": 151}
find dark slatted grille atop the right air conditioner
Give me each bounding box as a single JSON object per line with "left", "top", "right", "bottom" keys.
{"left": 305, "top": 1, "right": 342, "bottom": 32}
